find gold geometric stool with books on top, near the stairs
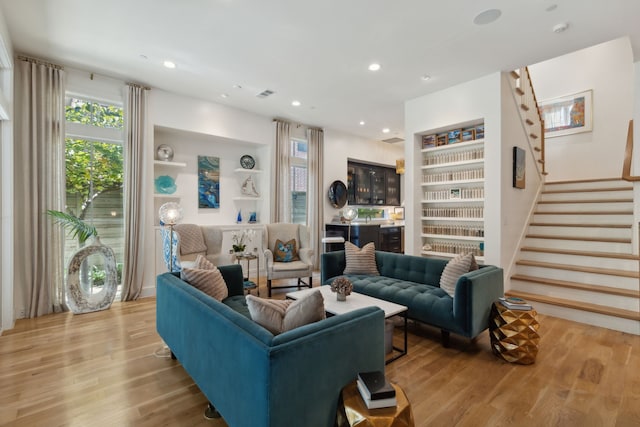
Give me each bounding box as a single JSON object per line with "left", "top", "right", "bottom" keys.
{"left": 489, "top": 301, "right": 540, "bottom": 365}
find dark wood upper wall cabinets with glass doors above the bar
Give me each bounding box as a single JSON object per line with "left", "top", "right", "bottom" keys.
{"left": 347, "top": 162, "right": 400, "bottom": 206}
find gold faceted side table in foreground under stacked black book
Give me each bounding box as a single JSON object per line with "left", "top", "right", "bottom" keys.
{"left": 336, "top": 381, "right": 415, "bottom": 427}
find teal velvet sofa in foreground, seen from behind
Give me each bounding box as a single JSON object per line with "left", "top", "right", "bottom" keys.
{"left": 156, "top": 265, "right": 384, "bottom": 427}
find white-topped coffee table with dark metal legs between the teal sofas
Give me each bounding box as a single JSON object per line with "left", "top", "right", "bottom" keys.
{"left": 286, "top": 285, "right": 408, "bottom": 363}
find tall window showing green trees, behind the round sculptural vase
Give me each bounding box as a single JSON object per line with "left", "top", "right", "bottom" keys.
{"left": 65, "top": 96, "right": 124, "bottom": 293}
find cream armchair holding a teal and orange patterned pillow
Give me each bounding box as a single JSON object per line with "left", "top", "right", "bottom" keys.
{"left": 262, "top": 223, "right": 315, "bottom": 296}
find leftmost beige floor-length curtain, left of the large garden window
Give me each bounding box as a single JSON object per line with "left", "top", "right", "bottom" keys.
{"left": 14, "top": 57, "right": 66, "bottom": 317}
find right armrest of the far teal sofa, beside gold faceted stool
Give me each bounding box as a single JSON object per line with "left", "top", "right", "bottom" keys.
{"left": 453, "top": 265, "right": 504, "bottom": 338}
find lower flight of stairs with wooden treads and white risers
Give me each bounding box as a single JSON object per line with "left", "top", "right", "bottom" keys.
{"left": 506, "top": 179, "right": 640, "bottom": 335}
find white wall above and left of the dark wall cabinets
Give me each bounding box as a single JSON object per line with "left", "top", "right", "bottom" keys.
{"left": 322, "top": 129, "right": 404, "bottom": 223}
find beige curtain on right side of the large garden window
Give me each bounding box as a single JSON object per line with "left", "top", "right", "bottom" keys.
{"left": 121, "top": 84, "right": 148, "bottom": 301}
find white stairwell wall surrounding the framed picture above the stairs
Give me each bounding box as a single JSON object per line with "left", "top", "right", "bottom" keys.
{"left": 529, "top": 37, "right": 634, "bottom": 181}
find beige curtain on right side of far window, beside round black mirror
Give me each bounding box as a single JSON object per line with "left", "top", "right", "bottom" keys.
{"left": 307, "top": 128, "right": 324, "bottom": 268}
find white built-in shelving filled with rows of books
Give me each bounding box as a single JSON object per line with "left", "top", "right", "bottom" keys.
{"left": 420, "top": 123, "right": 485, "bottom": 260}
